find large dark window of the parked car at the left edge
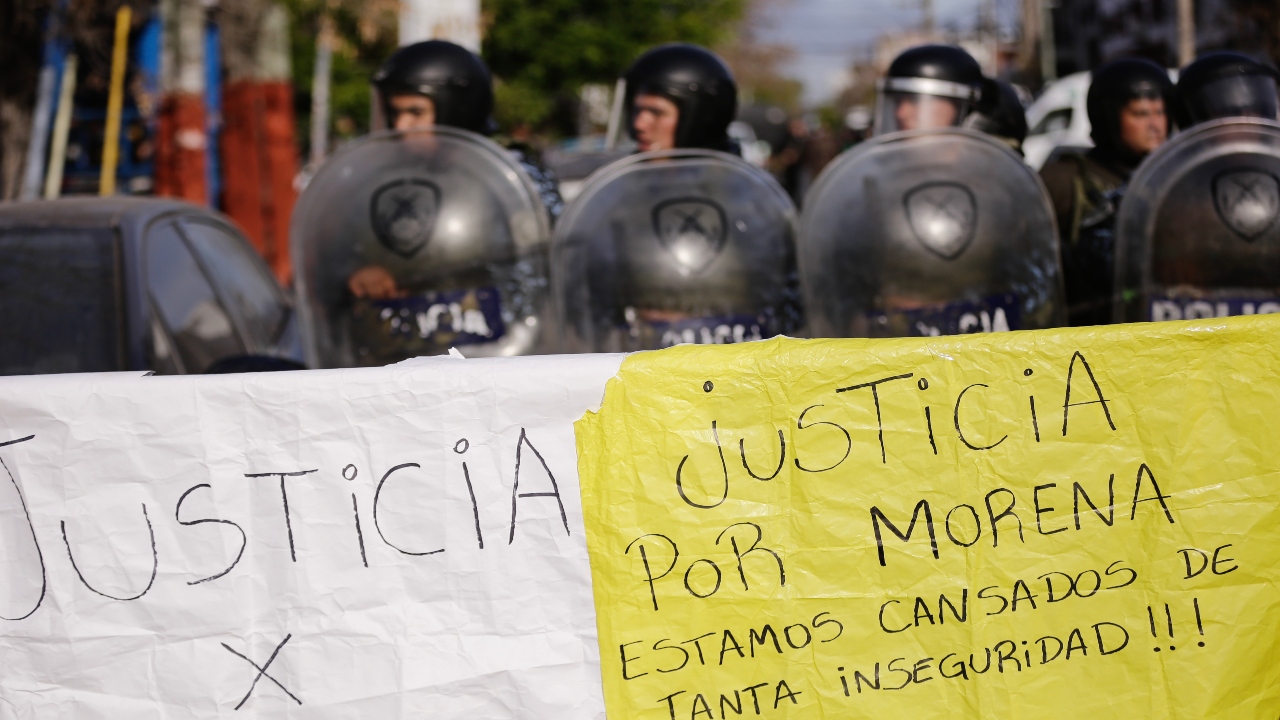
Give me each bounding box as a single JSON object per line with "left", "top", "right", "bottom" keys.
{"left": 0, "top": 228, "right": 124, "bottom": 375}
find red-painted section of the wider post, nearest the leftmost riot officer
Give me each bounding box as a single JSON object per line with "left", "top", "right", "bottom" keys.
{"left": 220, "top": 81, "right": 298, "bottom": 284}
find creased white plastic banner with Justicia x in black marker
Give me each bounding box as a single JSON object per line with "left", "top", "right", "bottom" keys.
{"left": 0, "top": 356, "right": 621, "bottom": 720}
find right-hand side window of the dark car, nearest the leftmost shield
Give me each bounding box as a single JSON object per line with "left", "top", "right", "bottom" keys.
{"left": 180, "top": 218, "right": 289, "bottom": 346}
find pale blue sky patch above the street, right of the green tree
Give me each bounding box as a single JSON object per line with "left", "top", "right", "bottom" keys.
{"left": 760, "top": 0, "right": 1021, "bottom": 104}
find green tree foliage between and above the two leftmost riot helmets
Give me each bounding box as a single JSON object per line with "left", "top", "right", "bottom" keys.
{"left": 481, "top": 0, "right": 748, "bottom": 135}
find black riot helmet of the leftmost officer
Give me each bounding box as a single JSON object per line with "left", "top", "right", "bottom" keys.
{"left": 374, "top": 40, "right": 493, "bottom": 133}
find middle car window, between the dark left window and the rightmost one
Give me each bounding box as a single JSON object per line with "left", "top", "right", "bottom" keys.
{"left": 146, "top": 220, "right": 246, "bottom": 373}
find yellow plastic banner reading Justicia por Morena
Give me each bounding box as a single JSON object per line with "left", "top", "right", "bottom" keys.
{"left": 577, "top": 318, "right": 1280, "bottom": 720}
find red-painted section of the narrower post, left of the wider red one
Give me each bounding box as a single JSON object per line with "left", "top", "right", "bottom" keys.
{"left": 155, "top": 94, "right": 209, "bottom": 205}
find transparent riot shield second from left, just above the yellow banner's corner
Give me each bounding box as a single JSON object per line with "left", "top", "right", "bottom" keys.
{"left": 552, "top": 150, "right": 801, "bottom": 352}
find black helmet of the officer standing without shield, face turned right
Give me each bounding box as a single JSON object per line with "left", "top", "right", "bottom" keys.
{"left": 1085, "top": 58, "right": 1174, "bottom": 165}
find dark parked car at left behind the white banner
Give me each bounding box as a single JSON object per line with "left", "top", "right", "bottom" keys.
{"left": 0, "top": 197, "right": 302, "bottom": 375}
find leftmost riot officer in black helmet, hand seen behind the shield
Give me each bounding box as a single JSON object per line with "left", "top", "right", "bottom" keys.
{"left": 347, "top": 40, "right": 564, "bottom": 300}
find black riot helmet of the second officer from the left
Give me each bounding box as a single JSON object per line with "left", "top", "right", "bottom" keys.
{"left": 622, "top": 42, "right": 737, "bottom": 150}
